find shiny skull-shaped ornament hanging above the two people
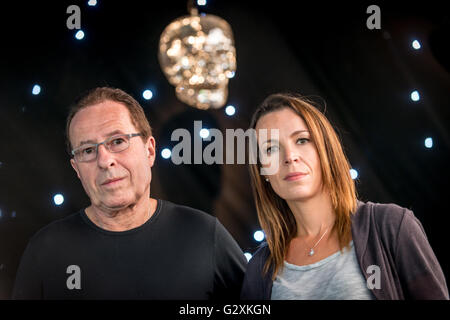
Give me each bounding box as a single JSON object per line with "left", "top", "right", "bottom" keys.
{"left": 158, "top": 2, "right": 236, "bottom": 109}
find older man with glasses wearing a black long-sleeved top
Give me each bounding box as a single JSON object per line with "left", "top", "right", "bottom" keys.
{"left": 13, "top": 88, "right": 246, "bottom": 299}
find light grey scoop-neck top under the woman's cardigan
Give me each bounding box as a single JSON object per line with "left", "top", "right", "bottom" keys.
{"left": 271, "top": 241, "right": 375, "bottom": 300}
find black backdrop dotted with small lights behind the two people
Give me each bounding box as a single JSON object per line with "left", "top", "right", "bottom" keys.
{"left": 0, "top": 0, "right": 450, "bottom": 299}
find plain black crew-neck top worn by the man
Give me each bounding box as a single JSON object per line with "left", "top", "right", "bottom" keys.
{"left": 13, "top": 200, "right": 247, "bottom": 300}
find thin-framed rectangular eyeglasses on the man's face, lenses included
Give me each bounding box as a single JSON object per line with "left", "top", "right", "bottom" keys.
{"left": 72, "top": 133, "right": 142, "bottom": 162}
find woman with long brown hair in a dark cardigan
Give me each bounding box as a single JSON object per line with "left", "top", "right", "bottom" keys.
{"left": 241, "top": 94, "right": 449, "bottom": 300}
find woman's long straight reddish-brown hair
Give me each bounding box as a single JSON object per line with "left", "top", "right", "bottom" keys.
{"left": 250, "top": 93, "right": 357, "bottom": 280}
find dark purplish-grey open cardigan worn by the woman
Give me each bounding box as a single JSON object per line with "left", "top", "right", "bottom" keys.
{"left": 241, "top": 201, "right": 449, "bottom": 300}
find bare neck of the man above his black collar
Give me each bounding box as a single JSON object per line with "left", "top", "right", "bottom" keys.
{"left": 85, "top": 198, "right": 158, "bottom": 232}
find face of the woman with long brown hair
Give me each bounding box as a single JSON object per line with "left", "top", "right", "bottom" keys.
{"left": 256, "top": 108, "right": 322, "bottom": 201}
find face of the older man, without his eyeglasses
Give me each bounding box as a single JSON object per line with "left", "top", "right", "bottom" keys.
{"left": 69, "top": 100, "right": 155, "bottom": 211}
